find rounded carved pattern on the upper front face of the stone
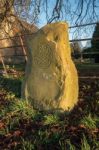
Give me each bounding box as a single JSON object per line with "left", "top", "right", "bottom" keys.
{"left": 33, "top": 44, "right": 53, "bottom": 69}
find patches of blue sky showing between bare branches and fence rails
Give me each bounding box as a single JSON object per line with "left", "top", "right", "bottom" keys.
{"left": 18, "top": 0, "right": 99, "bottom": 46}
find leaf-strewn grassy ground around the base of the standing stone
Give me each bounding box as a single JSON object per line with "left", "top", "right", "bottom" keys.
{"left": 0, "top": 66, "right": 99, "bottom": 150}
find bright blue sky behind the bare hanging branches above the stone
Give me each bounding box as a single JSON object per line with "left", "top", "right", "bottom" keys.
{"left": 16, "top": 0, "right": 99, "bottom": 47}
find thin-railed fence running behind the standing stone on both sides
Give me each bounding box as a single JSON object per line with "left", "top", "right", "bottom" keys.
{"left": 0, "top": 22, "right": 99, "bottom": 74}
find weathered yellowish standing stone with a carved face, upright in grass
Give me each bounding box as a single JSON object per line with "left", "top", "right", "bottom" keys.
{"left": 22, "top": 22, "right": 78, "bottom": 110}
